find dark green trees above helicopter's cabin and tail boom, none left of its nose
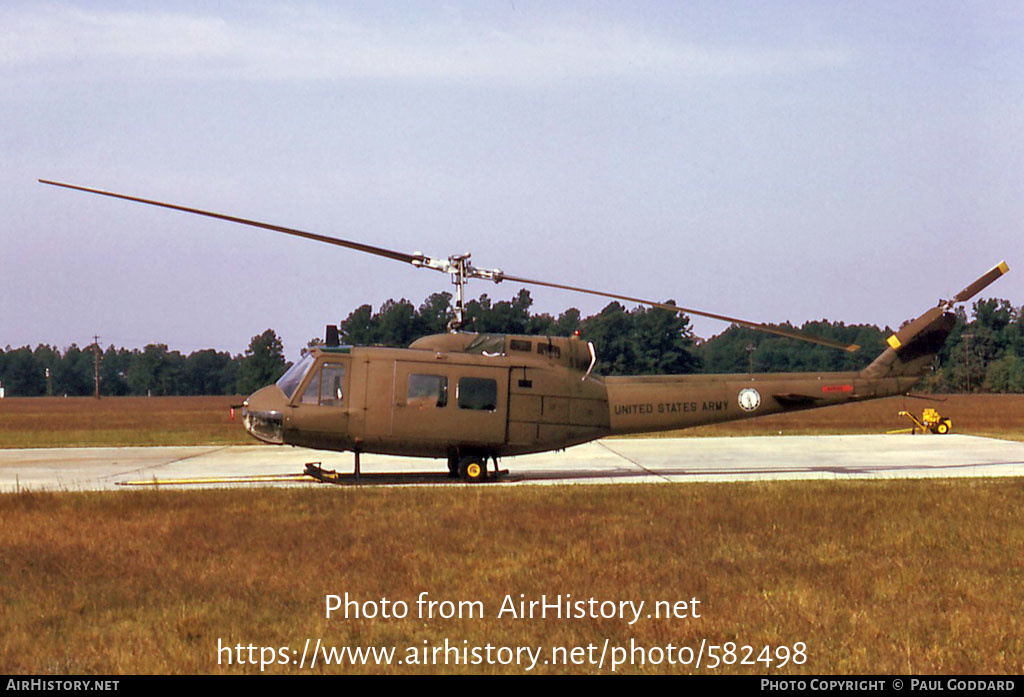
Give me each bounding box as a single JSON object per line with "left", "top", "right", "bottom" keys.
{"left": 339, "top": 290, "right": 1024, "bottom": 392}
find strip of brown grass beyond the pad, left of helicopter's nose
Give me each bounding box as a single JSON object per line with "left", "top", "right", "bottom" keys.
{"left": 0, "top": 396, "right": 256, "bottom": 447}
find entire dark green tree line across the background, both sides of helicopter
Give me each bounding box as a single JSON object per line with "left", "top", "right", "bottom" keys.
{"left": 0, "top": 290, "right": 1024, "bottom": 396}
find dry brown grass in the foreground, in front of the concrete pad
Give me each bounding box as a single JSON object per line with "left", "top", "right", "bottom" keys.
{"left": 0, "top": 480, "right": 1024, "bottom": 673}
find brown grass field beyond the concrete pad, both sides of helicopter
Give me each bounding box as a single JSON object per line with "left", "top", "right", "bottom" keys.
{"left": 0, "top": 395, "right": 1024, "bottom": 447}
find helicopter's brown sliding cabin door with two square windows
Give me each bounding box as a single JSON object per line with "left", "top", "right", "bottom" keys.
{"left": 391, "top": 361, "right": 509, "bottom": 445}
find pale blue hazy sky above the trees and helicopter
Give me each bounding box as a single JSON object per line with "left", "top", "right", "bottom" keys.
{"left": 0, "top": 0, "right": 1024, "bottom": 360}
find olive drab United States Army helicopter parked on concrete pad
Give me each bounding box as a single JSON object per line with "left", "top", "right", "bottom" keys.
{"left": 39, "top": 179, "right": 1009, "bottom": 482}
